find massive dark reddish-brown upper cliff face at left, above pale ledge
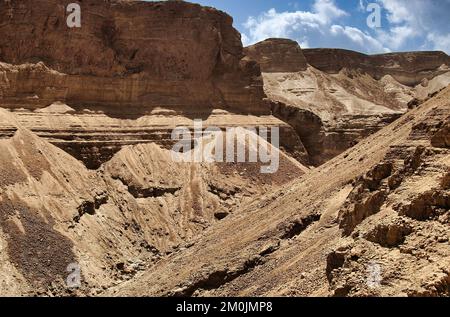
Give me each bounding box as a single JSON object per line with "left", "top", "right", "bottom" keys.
{"left": 0, "top": 0, "right": 268, "bottom": 113}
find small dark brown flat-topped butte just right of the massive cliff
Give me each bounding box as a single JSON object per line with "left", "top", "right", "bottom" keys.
{"left": 245, "top": 38, "right": 307, "bottom": 73}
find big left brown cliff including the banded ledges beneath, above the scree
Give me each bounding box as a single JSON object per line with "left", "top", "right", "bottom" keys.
{"left": 0, "top": 0, "right": 307, "bottom": 169}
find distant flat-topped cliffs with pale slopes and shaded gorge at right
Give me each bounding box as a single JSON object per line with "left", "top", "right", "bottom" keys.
{"left": 245, "top": 39, "right": 450, "bottom": 165}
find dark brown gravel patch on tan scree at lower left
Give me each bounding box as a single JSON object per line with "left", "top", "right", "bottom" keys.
{"left": 0, "top": 194, "right": 76, "bottom": 288}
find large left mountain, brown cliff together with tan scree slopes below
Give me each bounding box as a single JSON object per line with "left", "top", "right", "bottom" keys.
{"left": 0, "top": 0, "right": 308, "bottom": 296}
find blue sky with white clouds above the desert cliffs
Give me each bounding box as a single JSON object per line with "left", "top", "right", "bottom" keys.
{"left": 192, "top": 0, "right": 450, "bottom": 54}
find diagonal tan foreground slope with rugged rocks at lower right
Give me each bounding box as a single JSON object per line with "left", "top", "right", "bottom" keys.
{"left": 106, "top": 88, "right": 450, "bottom": 296}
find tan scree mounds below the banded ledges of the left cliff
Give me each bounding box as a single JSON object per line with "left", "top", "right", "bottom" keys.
{"left": 0, "top": 109, "right": 307, "bottom": 295}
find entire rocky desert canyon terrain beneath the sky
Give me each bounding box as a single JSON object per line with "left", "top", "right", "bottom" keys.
{"left": 0, "top": 0, "right": 450, "bottom": 296}
